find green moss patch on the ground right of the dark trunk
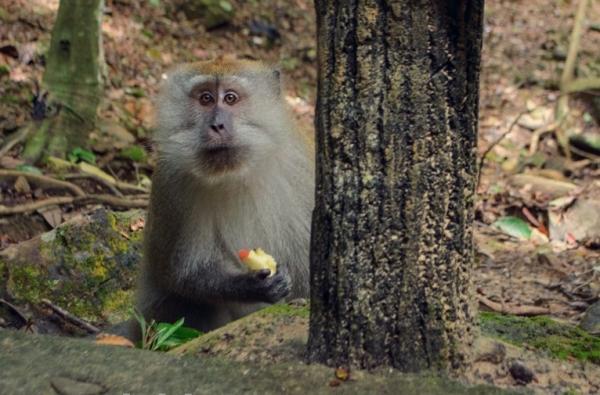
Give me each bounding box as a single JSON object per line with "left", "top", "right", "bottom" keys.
{"left": 480, "top": 312, "right": 600, "bottom": 365}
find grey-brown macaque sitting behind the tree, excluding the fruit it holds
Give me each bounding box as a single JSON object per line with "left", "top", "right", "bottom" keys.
{"left": 137, "top": 57, "right": 314, "bottom": 338}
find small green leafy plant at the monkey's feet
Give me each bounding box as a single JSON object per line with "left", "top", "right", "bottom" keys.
{"left": 133, "top": 309, "right": 201, "bottom": 351}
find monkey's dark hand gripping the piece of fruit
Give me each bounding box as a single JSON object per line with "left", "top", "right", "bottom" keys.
{"left": 244, "top": 266, "right": 292, "bottom": 303}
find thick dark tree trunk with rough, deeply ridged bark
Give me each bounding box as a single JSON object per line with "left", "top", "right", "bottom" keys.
{"left": 307, "top": 0, "right": 483, "bottom": 372}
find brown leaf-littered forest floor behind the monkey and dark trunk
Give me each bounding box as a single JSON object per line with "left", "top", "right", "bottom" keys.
{"left": 0, "top": 0, "right": 600, "bottom": 392}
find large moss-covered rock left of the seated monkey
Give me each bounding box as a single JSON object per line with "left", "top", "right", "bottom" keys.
{"left": 0, "top": 209, "right": 144, "bottom": 333}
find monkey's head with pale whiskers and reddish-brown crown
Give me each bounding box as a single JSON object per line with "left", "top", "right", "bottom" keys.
{"left": 156, "top": 59, "right": 291, "bottom": 182}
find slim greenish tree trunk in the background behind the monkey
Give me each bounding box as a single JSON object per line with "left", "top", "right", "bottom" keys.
{"left": 23, "top": 0, "right": 104, "bottom": 162}
